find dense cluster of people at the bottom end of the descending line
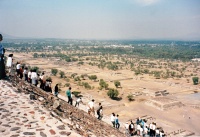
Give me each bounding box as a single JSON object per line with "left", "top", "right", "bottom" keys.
{"left": 125, "top": 118, "right": 165, "bottom": 137}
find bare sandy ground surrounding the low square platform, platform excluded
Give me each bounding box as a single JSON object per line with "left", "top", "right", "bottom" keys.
{"left": 5, "top": 53, "right": 200, "bottom": 136}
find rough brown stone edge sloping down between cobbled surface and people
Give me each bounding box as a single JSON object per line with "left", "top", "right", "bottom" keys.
{"left": 10, "top": 76, "right": 125, "bottom": 137}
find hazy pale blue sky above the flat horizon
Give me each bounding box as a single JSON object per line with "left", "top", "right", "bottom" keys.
{"left": 0, "top": 0, "right": 200, "bottom": 40}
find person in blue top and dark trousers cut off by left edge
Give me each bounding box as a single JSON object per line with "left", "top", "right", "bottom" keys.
{"left": 0, "top": 34, "right": 6, "bottom": 79}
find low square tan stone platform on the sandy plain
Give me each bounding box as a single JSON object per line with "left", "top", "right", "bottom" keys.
{"left": 145, "top": 97, "right": 184, "bottom": 111}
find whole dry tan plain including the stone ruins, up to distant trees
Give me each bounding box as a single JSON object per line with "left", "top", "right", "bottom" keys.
{"left": 6, "top": 50, "right": 200, "bottom": 136}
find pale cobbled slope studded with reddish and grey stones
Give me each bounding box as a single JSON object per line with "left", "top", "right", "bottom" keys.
{"left": 0, "top": 80, "right": 81, "bottom": 137}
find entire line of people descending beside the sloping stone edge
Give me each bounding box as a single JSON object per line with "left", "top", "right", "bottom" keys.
{"left": 0, "top": 34, "right": 165, "bottom": 137}
